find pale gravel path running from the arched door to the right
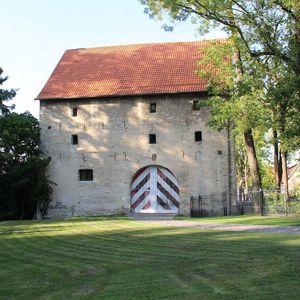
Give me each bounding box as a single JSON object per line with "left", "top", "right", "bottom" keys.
{"left": 141, "top": 220, "right": 300, "bottom": 234}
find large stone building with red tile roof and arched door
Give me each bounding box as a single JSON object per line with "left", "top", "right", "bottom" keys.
{"left": 37, "top": 41, "right": 236, "bottom": 217}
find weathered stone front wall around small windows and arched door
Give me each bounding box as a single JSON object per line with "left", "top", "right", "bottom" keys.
{"left": 40, "top": 93, "right": 236, "bottom": 217}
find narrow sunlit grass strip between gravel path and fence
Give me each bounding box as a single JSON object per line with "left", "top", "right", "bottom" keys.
{"left": 176, "top": 215, "right": 300, "bottom": 226}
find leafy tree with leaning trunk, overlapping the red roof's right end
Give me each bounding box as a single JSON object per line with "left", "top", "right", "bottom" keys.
{"left": 199, "top": 40, "right": 269, "bottom": 213}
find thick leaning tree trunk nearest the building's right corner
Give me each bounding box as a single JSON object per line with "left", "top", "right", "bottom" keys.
{"left": 244, "top": 129, "right": 263, "bottom": 215}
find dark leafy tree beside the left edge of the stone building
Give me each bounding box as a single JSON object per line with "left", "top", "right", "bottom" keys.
{"left": 0, "top": 113, "right": 52, "bottom": 220}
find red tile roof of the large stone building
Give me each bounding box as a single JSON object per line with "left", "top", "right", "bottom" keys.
{"left": 37, "top": 40, "right": 226, "bottom": 100}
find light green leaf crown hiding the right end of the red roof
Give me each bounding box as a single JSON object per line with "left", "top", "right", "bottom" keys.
{"left": 198, "top": 40, "right": 270, "bottom": 133}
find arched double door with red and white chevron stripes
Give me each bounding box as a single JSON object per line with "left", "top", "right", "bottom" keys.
{"left": 131, "top": 166, "right": 180, "bottom": 213}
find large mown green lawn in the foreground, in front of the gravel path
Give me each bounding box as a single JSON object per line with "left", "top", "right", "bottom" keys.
{"left": 0, "top": 217, "right": 300, "bottom": 299}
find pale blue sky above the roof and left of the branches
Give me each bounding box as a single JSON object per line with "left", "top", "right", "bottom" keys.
{"left": 0, "top": 0, "right": 225, "bottom": 117}
